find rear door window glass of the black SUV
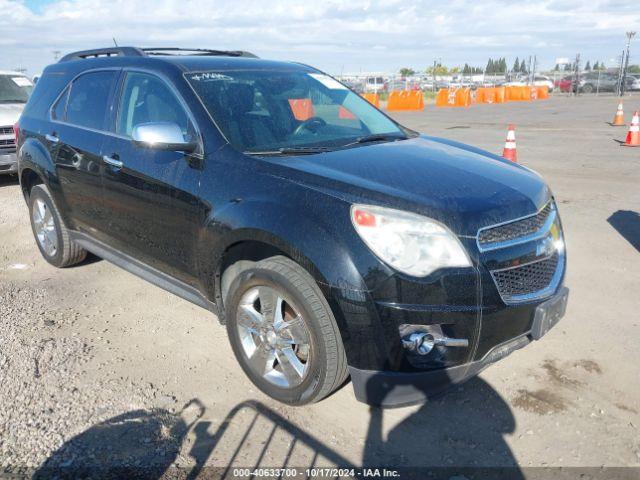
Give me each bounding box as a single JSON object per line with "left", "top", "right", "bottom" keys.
{"left": 66, "top": 71, "right": 116, "bottom": 130}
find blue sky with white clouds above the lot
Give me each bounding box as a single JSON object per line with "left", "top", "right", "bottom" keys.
{"left": 0, "top": 0, "right": 640, "bottom": 75}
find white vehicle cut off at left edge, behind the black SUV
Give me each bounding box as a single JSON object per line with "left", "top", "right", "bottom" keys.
{"left": 0, "top": 70, "right": 33, "bottom": 175}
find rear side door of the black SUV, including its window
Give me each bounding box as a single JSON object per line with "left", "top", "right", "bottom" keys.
{"left": 45, "top": 70, "right": 118, "bottom": 238}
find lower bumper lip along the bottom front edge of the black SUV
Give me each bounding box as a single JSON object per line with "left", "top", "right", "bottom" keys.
{"left": 349, "top": 287, "right": 569, "bottom": 407}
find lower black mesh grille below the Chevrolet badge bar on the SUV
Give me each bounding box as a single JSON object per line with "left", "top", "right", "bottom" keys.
{"left": 491, "top": 252, "right": 560, "bottom": 302}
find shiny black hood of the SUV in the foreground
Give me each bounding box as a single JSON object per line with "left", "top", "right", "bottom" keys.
{"left": 264, "top": 136, "right": 550, "bottom": 236}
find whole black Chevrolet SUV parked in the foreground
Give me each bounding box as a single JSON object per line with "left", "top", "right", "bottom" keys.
{"left": 16, "top": 47, "right": 568, "bottom": 406}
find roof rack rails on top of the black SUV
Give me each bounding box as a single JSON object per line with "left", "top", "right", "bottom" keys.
{"left": 60, "top": 47, "right": 258, "bottom": 62}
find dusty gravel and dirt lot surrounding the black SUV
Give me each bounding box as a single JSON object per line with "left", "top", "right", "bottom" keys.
{"left": 0, "top": 97, "right": 640, "bottom": 476}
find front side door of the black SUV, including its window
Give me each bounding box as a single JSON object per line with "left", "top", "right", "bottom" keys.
{"left": 103, "top": 67, "right": 203, "bottom": 285}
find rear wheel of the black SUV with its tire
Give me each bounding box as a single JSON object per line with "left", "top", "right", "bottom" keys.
{"left": 29, "top": 185, "right": 87, "bottom": 268}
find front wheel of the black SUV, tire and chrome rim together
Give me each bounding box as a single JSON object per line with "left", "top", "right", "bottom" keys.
{"left": 224, "top": 256, "right": 348, "bottom": 405}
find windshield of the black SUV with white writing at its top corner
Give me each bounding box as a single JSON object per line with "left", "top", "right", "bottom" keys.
{"left": 185, "top": 70, "right": 406, "bottom": 153}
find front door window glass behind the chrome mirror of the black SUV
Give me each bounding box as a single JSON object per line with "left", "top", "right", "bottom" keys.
{"left": 117, "top": 72, "right": 194, "bottom": 138}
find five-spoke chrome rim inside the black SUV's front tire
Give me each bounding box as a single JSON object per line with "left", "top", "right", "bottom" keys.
{"left": 236, "top": 286, "right": 312, "bottom": 388}
